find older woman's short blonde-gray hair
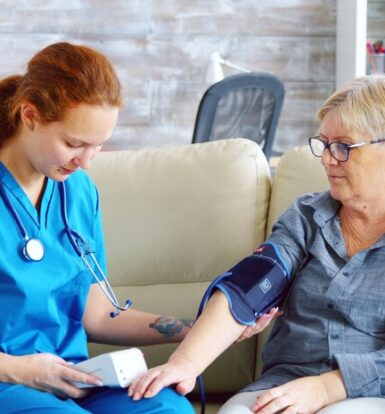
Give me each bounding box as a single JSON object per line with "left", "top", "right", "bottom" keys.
{"left": 317, "top": 75, "right": 385, "bottom": 138}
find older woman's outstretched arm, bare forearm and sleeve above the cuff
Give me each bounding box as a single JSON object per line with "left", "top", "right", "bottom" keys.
{"left": 129, "top": 201, "right": 306, "bottom": 399}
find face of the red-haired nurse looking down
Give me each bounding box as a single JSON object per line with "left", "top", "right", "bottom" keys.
{"left": 25, "top": 104, "right": 119, "bottom": 181}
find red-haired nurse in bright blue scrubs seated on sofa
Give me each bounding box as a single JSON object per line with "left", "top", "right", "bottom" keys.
{"left": 0, "top": 43, "right": 194, "bottom": 414}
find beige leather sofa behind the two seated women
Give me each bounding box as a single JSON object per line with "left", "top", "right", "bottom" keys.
{"left": 86, "top": 139, "right": 327, "bottom": 413}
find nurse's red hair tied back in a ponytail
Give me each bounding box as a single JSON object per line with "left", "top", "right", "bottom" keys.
{"left": 0, "top": 42, "right": 122, "bottom": 145}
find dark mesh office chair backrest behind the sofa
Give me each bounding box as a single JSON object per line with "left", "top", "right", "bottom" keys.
{"left": 192, "top": 72, "right": 285, "bottom": 159}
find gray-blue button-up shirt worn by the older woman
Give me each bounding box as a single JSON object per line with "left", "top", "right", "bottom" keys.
{"left": 244, "top": 192, "right": 385, "bottom": 398}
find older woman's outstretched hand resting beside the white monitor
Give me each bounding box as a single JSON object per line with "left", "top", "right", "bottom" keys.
{"left": 128, "top": 356, "right": 198, "bottom": 400}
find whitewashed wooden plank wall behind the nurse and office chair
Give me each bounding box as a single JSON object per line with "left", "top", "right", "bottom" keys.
{"left": 0, "top": 0, "right": 336, "bottom": 151}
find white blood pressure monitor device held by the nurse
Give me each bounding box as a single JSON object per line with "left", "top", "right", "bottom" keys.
{"left": 73, "top": 348, "right": 147, "bottom": 388}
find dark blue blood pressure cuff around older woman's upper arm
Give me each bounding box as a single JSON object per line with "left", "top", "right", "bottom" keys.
{"left": 201, "top": 243, "right": 290, "bottom": 325}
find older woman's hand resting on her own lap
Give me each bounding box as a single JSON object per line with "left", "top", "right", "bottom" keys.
{"left": 252, "top": 370, "right": 346, "bottom": 414}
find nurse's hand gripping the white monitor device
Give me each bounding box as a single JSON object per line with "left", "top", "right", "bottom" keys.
{"left": 10, "top": 354, "right": 103, "bottom": 398}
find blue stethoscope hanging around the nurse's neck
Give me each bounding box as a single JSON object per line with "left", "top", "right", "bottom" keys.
{"left": 0, "top": 182, "right": 132, "bottom": 318}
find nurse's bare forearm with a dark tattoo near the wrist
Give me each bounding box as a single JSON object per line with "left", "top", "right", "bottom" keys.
{"left": 83, "top": 283, "right": 193, "bottom": 346}
